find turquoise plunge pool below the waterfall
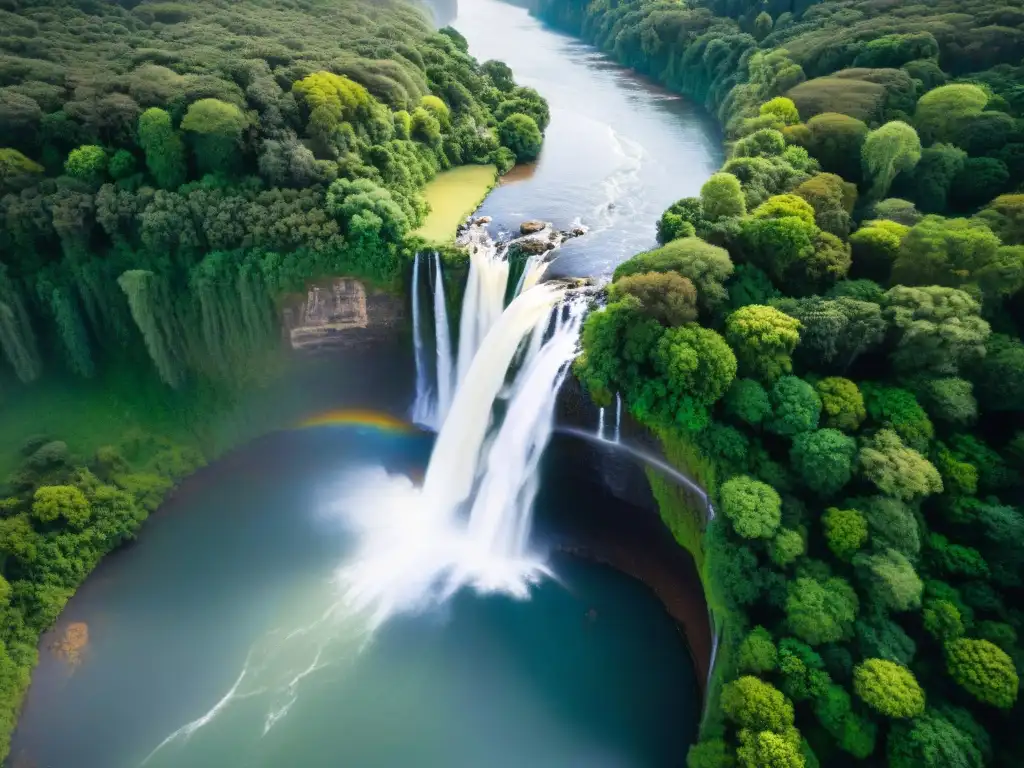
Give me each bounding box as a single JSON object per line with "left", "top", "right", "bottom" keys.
{"left": 12, "top": 428, "right": 698, "bottom": 768}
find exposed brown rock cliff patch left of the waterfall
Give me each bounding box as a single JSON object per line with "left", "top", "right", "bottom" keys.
{"left": 282, "top": 278, "right": 407, "bottom": 350}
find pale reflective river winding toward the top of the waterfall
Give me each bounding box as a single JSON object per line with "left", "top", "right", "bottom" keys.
{"left": 454, "top": 0, "right": 723, "bottom": 275}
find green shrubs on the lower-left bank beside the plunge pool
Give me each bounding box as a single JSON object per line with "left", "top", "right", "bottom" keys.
{"left": 0, "top": 433, "right": 203, "bottom": 752}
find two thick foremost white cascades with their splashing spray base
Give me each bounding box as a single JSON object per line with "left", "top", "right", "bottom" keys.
{"left": 339, "top": 284, "right": 585, "bottom": 627}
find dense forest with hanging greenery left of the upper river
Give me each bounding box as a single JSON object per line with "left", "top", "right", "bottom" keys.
{"left": 0, "top": 0, "right": 548, "bottom": 386}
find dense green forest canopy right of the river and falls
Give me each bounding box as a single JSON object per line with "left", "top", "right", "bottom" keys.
{"left": 539, "top": 0, "right": 1024, "bottom": 768}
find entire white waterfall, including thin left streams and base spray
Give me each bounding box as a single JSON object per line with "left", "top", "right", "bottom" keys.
{"left": 340, "top": 221, "right": 589, "bottom": 622}
